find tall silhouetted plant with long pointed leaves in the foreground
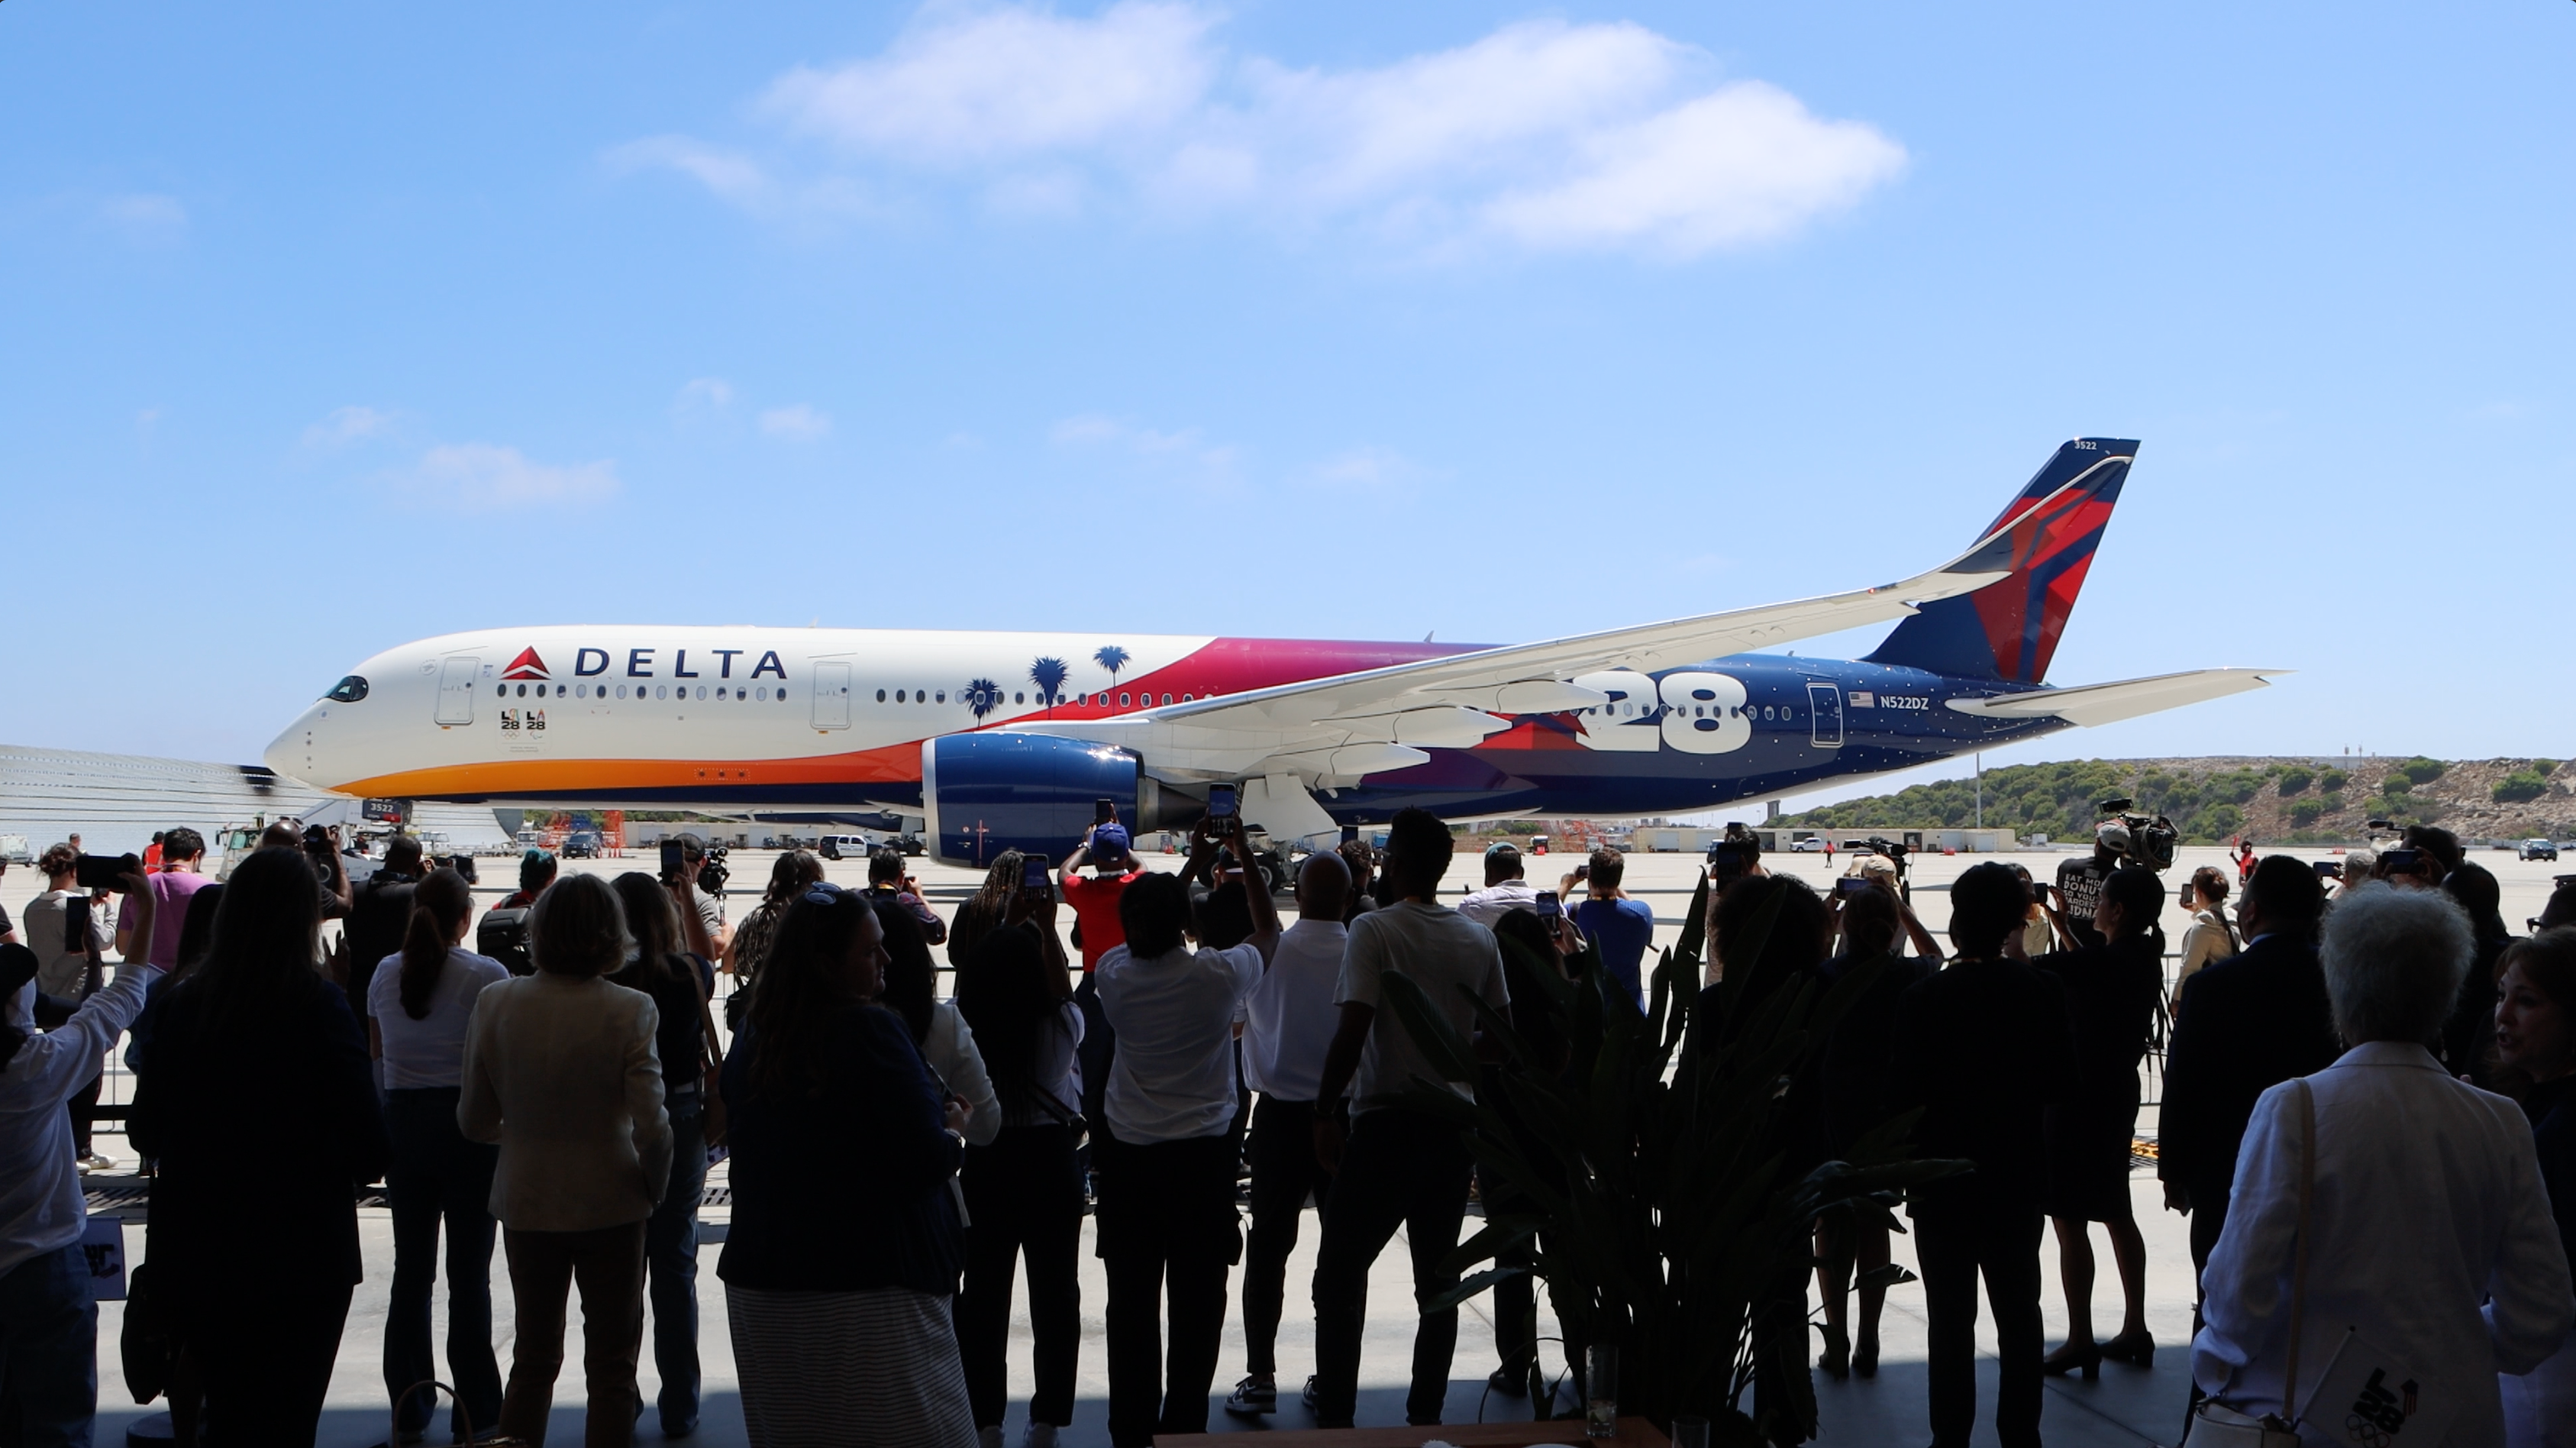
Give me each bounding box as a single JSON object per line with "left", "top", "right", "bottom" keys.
{"left": 1386, "top": 871, "right": 1965, "bottom": 1446}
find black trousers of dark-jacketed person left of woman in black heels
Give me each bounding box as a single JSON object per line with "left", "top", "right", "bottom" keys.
{"left": 1914, "top": 1198, "right": 2045, "bottom": 1448}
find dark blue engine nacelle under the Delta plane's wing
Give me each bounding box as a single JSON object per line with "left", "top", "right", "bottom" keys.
{"left": 922, "top": 729, "right": 1159, "bottom": 868}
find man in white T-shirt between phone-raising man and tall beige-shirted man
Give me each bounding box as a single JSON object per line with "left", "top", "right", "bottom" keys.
{"left": 1226, "top": 850, "right": 1350, "bottom": 1417}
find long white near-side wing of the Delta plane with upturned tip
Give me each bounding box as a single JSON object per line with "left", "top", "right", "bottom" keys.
{"left": 1018, "top": 525, "right": 2012, "bottom": 781}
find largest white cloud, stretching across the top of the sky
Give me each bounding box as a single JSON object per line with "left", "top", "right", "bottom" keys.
{"left": 611, "top": 0, "right": 1906, "bottom": 257}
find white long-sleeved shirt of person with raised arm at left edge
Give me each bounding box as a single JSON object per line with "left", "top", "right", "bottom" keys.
{"left": 0, "top": 964, "right": 160, "bottom": 1273}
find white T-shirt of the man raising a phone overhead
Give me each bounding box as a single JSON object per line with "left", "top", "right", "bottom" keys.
{"left": 1093, "top": 945, "right": 1262, "bottom": 1146}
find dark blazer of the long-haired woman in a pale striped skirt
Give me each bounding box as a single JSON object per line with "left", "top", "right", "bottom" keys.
{"left": 716, "top": 1005, "right": 966, "bottom": 1296}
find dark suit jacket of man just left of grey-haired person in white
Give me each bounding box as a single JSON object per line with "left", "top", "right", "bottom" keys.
{"left": 2156, "top": 936, "right": 2344, "bottom": 1195}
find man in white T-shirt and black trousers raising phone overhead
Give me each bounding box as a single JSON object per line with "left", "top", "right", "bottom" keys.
{"left": 1093, "top": 822, "right": 1280, "bottom": 1448}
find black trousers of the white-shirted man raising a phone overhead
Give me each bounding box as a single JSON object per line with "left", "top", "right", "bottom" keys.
{"left": 1093, "top": 1131, "right": 1244, "bottom": 1448}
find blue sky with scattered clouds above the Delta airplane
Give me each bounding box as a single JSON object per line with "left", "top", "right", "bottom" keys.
{"left": 0, "top": 0, "right": 2576, "bottom": 793}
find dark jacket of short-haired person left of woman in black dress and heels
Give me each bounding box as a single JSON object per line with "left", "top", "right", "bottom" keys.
{"left": 1891, "top": 961, "right": 2076, "bottom": 1216}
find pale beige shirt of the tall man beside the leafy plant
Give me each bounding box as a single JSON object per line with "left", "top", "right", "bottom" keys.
{"left": 1328, "top": 899, "right": 1512, "bottom": 1110}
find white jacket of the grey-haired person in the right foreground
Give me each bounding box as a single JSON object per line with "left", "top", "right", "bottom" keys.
{"left": 2192, "top": 1041, "right": 2576, "bottom": 1448}
